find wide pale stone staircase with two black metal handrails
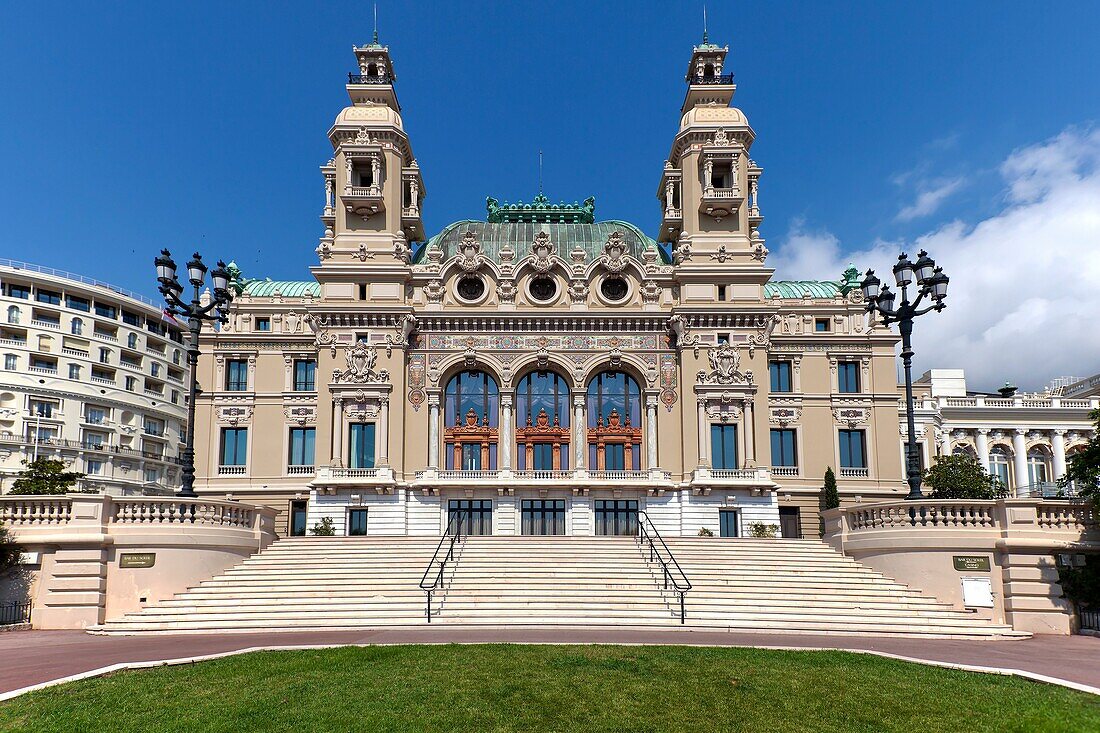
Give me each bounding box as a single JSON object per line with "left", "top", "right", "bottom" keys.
{"left": 90, "top": 530, "right": 1021, "bottom": 637}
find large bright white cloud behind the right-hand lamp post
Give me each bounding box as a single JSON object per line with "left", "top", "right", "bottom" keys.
{"left": 769, "top": 129, "right": 1100, "bottom": 389}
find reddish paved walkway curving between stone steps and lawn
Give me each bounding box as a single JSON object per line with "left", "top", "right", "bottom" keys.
{"left": 0, "top": 626, "right": 1100, "bottom": 700}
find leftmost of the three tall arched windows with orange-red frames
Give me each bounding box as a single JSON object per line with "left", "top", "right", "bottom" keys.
{"left": 443, "top": 371, "right": 501, "bottom": 471}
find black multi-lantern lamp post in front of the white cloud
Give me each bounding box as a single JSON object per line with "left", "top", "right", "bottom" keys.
{"left": 860, "top": 250, "right": 948, "bottom": 499}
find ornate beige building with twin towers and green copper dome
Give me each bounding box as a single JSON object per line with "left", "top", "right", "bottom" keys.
{"left": 196, "top": 34, "right": 919, "bottom": 537}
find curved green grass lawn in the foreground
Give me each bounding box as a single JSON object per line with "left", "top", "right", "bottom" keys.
{"left": 0, "top": 645, "right": 1100, "bottom": 733}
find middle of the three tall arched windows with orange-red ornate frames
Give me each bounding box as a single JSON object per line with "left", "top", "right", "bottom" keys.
{"left": 516, "top": 371, "right": 569, "bottom": 471}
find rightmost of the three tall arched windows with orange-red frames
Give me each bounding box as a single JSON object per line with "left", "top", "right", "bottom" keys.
{"left": 589, "top": 371, "right": 641, "bottom": 471}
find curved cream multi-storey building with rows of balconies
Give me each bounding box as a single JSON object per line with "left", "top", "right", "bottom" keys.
{"left": 0, "top": 260, "right": 188, "bottom": 494}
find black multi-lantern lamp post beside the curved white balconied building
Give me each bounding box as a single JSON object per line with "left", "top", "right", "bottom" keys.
{"left": 154, "top": 250, "right": 233, "bottom": 499}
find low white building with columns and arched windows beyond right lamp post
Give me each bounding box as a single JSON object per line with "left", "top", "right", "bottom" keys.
{"left": 901, "top": 369, "right": 1100, "bottom": 496}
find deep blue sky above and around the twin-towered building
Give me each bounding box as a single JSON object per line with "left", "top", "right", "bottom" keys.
{"left": 0, "top": 1, "right": 1100, "bottom": 386}
